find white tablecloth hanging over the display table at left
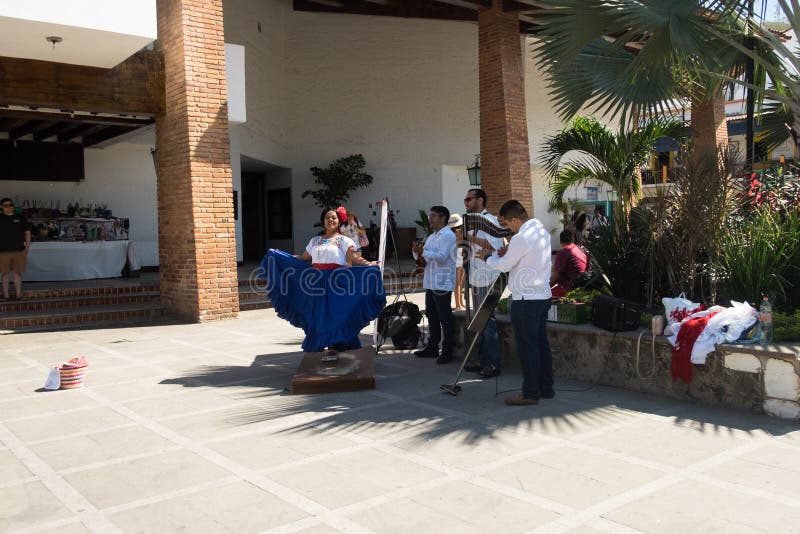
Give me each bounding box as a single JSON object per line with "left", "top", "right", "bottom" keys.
{"left": 22, "top": 241, "right": 128, "bottom": 282}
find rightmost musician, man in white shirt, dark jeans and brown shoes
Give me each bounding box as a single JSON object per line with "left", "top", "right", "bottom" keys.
{"left": 482, "top": 200, "right": 555, "bottom": 406}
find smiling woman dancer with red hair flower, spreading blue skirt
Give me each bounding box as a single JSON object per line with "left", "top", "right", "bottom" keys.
{"left": 261, "top": 208, "right": 386, "bottom": 352}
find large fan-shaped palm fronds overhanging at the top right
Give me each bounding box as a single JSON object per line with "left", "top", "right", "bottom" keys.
{"left": 535, "top": 0, "right": 780, "bottom": 153}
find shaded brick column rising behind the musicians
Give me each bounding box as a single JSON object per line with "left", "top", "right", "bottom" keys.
{"left": 478, "top": 0, "right": 533, "bottom": 215}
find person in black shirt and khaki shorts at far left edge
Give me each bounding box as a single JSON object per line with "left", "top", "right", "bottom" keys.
{"left": 0, "top": 198, "right": 31, "bottom": 300}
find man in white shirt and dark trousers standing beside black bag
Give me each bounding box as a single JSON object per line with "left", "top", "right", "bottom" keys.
{"left": 414, "top": 206, "right": 456, "bottom": 363}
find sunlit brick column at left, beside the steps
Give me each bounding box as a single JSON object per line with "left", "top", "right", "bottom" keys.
{"left": 156, "top": 0, "right": 239, "bottom": 321}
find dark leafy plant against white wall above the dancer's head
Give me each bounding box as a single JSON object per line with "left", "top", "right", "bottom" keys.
{"left": 301, "top": 154, "right": 372, "bottom": 208}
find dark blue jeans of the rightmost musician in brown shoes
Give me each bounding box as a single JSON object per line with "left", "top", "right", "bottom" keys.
{"left": 511, "top": 299, "right": 553, "bottom": 399}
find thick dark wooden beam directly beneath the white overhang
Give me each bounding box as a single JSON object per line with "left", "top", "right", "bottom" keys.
{"left": 0, "top": 50, "right": 165, "bottom": 117}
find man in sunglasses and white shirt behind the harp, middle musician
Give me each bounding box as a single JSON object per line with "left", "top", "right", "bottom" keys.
{"left": 464, "top": 188, "right": 503, "bottom": 378}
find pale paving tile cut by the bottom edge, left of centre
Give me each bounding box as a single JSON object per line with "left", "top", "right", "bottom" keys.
{"left": 110, "top": 481, "right": 307, "bottom": 534}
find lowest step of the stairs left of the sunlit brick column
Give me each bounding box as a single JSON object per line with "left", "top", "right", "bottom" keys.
{"left": 0, "top": 302, "right": 164, "bottom": 330}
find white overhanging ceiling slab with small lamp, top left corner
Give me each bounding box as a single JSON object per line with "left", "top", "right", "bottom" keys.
{"left": 0, "top": 0, "right": 156, "bottom": 68}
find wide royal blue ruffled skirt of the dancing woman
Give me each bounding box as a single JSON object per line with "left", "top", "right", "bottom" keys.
{"left": 259, "top": 249, "right": 386, "bottom": 352}
